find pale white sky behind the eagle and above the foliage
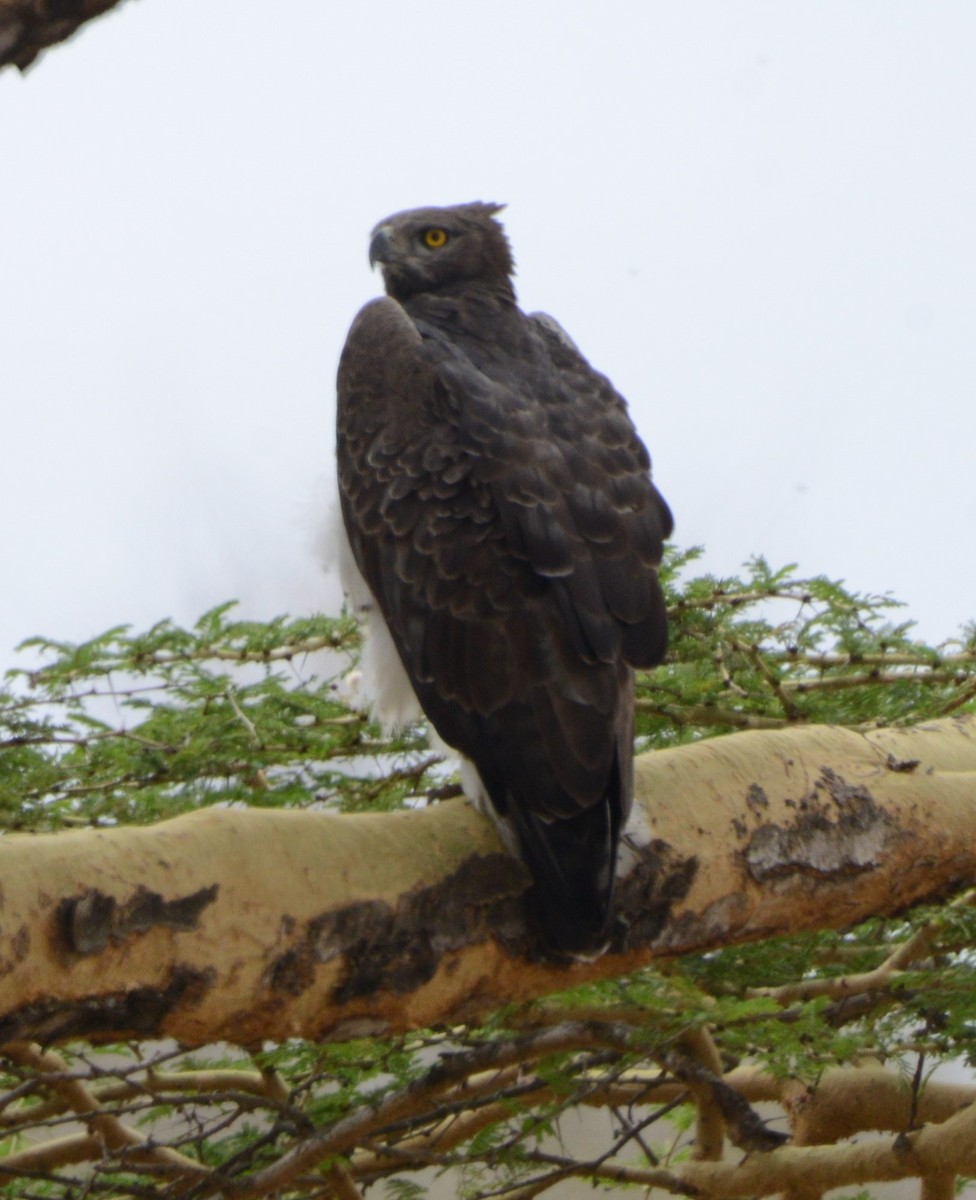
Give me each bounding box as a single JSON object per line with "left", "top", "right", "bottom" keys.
{"left": 0, "top": 0, "right": 976, "bottom": 665}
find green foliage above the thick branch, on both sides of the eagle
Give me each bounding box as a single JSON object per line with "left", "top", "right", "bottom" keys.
{"left": 0, "top": 550, "right": 976, "bottom": 829}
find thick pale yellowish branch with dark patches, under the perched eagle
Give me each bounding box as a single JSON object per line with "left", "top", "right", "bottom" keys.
{"left": 0, "top": 718, "right": 976, "bottom": 1045}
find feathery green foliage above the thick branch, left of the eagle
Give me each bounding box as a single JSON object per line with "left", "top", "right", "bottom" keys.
{"left": 0, "top": 605, "right": 436, "bottom": 829}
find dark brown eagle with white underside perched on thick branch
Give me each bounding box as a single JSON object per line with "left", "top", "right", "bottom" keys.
{"left": 336, "top": 202, "right": 672, "bottom": 958}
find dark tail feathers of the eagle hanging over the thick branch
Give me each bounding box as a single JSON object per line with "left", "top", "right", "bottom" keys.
{"left": 511, "top": 800, "right": 618, "bottom": 958}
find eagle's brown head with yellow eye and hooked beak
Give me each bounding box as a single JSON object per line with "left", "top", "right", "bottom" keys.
{"left": 370, "top": 200, "right": 515, "bottom": 300}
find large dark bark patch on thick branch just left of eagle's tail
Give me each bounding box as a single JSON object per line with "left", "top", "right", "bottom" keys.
{"left": 264, "top": 854, "right": 528, "bottom": 1004}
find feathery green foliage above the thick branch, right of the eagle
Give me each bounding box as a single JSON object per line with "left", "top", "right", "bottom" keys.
{"left": 637, "top": 550, "right": 976, "bottom": 746}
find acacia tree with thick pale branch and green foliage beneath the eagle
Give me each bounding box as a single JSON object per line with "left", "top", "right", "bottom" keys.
{"left": 0, "top": 553, "right": 976, "bottom": 1200}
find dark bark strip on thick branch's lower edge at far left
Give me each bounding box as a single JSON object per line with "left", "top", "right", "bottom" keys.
{"left": 0, "top": 965, "right": 216, "bottom": 1045}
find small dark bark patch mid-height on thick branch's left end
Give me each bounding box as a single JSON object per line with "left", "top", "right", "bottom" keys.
{"left": 58, "top": 883, "right": 218, "bottom": 955}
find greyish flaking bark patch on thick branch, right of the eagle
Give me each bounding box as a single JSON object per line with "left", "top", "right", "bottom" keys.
{"left": 744, "top": 767, "right": 900, "bottom": 883}
